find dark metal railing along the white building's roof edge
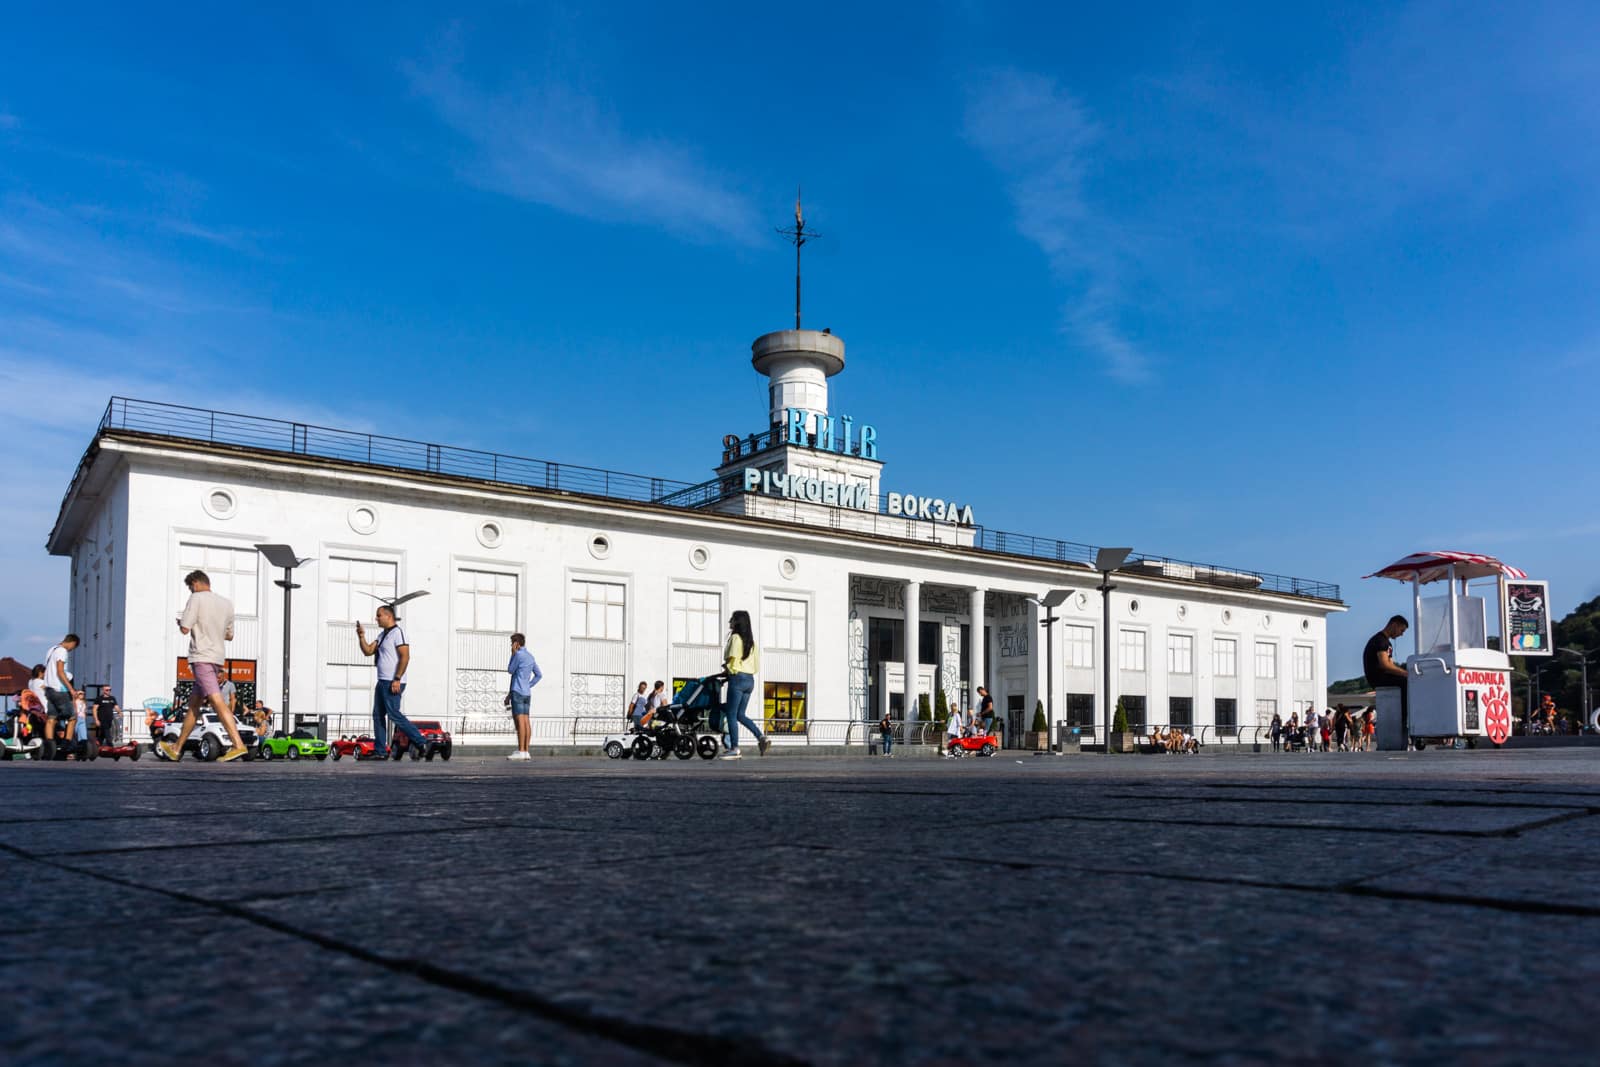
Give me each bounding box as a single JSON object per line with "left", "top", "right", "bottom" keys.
{"left": 99, "top": 397, "right": 1339, "bottom": 600}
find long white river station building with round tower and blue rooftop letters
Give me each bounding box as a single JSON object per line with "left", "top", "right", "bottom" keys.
{"left": 50, "top": 330, "right": 1344, "bottom": 744}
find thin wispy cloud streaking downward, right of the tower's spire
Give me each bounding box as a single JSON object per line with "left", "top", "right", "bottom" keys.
{"left": 965, "top": 70, "right": 1152, "bottom": 384}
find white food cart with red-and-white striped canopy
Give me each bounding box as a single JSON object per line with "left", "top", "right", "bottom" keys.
{"left": 1366, "top": 552, "right": 1547, "bottom": 752}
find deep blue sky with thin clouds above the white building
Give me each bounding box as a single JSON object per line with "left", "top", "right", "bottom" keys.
{"left": 0, "top": 3, "right": 1600, "bottom": 678}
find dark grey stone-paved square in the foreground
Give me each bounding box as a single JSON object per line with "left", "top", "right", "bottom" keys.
{"left": 0, "top": 750, "right": 1600, "bottom": 1065}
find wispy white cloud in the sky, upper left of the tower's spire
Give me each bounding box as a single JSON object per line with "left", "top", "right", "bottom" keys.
{"left": 403, "top": 41, "right": 763, "bottom": 243}
